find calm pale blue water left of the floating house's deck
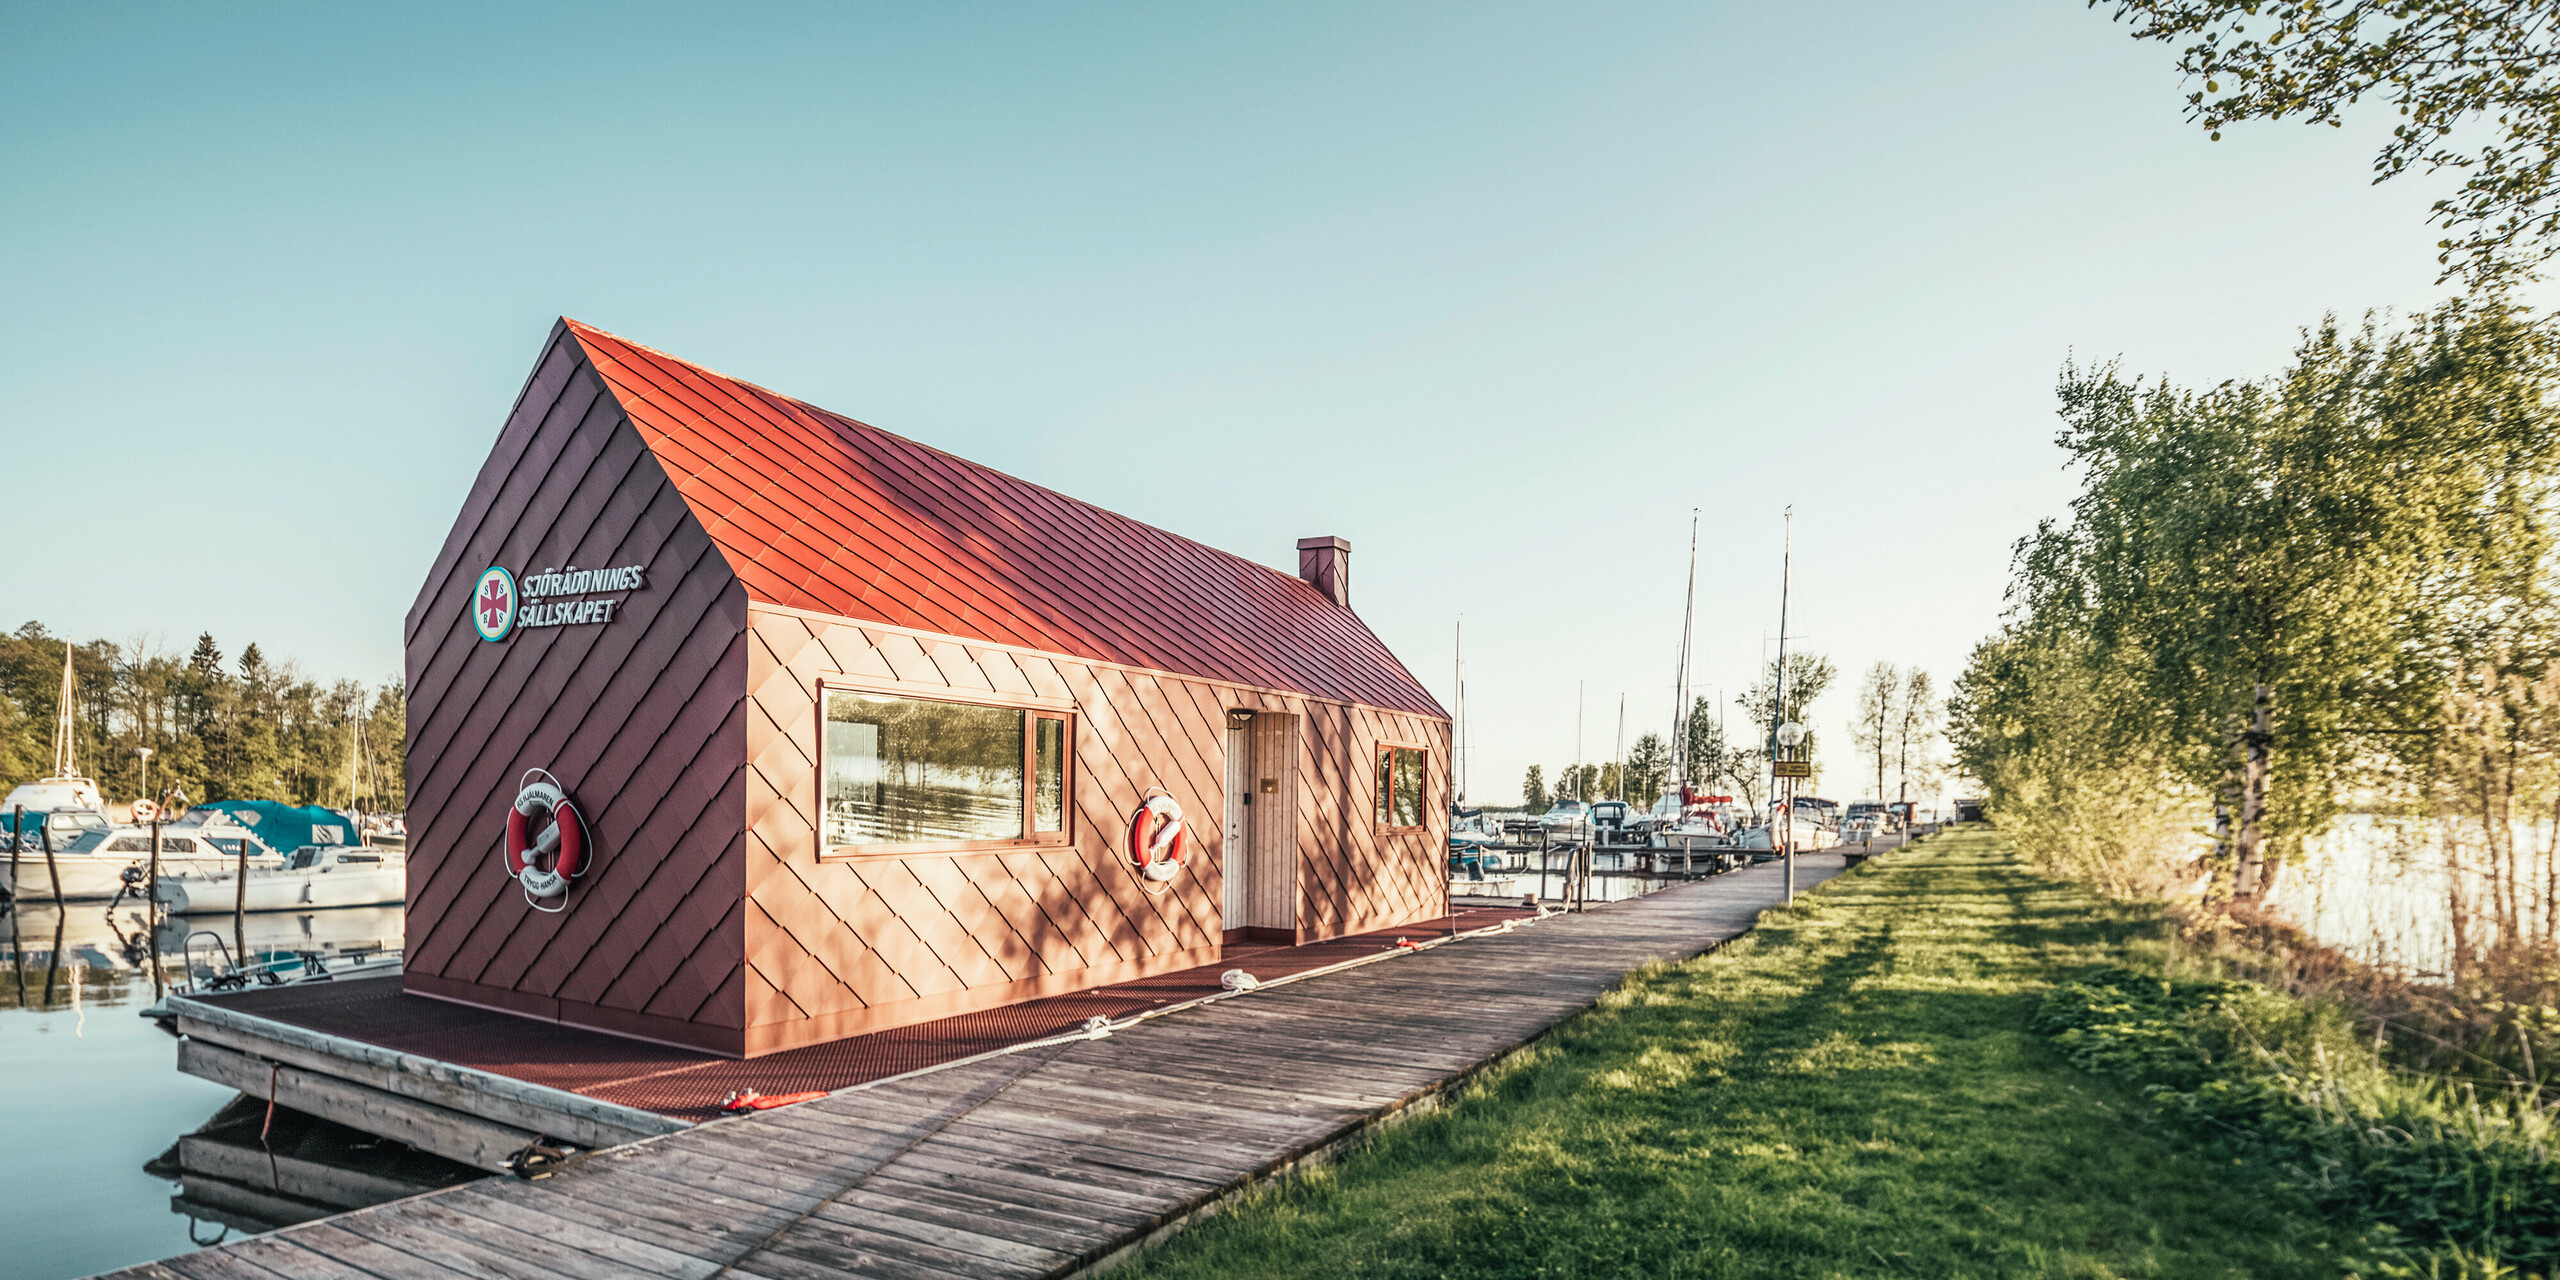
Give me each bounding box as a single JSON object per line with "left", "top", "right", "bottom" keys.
{"left": 0, "top": 901, "right": 402, "bottom": 1280}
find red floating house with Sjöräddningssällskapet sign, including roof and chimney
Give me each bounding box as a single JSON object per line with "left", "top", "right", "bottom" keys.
{"left": 402, "top": 320, "right": 1449, "bottom": 1057}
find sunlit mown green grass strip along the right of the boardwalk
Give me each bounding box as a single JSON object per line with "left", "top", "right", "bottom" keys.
{"left": 1119, "top": 832, "right": 2360, "bottom": 1277}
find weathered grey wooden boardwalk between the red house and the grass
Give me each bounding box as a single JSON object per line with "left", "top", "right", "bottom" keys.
{"left": 115, "top": 852, "right": 1843, "bottom": 1280}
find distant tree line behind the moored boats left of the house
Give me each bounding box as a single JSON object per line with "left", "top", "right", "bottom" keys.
{"left": 0, "top": 622, "right": 407, "bottom": 812}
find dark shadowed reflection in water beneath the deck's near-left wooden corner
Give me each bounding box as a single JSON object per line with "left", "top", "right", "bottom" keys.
{"left": 143, "top": 1093, "right": 481, "bottom": 1244}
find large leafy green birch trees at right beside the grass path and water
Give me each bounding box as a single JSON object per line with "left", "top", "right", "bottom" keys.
{"left": 1951, "top": 302, "right": 2560, "bottom": 899}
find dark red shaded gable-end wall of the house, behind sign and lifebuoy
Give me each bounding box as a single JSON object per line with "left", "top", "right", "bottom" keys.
{"left": 404, "top": 328, "right": 748, "bottom": 1052}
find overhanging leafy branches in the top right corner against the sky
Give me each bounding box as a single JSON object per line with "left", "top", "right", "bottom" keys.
{"left": 2089, "top": 0, "right": 2560, "bottom": 284}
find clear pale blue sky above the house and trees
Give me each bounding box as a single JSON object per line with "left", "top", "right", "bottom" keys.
{"left": 0, "top": 0, "right": 2519, "bottom": 801}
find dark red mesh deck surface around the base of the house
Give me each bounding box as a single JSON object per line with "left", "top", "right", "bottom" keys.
{"left": 197, "top": 906, "right": 1533, "bottom": 1119}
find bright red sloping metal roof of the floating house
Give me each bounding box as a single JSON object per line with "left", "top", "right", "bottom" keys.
{"left": 561, "top": 320, "right": 1446, "bottom": 717}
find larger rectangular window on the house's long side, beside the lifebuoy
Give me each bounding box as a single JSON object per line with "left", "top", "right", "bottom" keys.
{"left": 819, "top": 689, "right": 1068, "bottom": 852}
